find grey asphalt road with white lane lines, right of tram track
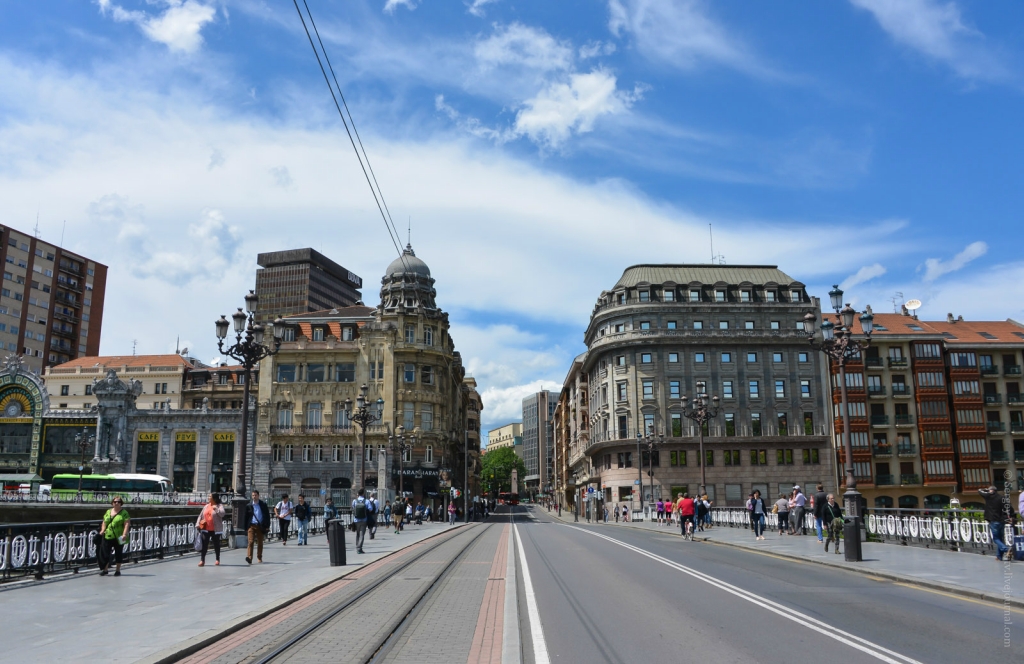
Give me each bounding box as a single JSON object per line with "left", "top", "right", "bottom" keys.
{"left": 507, "top": 507, "right": 1024, "bottom": 664}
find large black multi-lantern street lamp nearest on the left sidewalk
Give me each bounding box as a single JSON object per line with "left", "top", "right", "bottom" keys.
{"left": 210, "top": 291, "right": 285, "bottom": 538}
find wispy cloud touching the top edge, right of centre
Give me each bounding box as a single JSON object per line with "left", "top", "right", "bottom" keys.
{"left": 608, "top": 0, "right": 775, "bottom": 76}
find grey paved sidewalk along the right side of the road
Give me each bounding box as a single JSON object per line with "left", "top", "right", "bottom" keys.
{"left": 534, "top": 506, "right": 1024, "bottom": 607}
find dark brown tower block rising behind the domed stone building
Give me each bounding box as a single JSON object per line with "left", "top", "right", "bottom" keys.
{"left": 256, "top": 248, "right": 362, "bottom": 325}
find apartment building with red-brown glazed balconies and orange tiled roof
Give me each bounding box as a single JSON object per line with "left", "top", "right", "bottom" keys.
{"left": 833, "top": 314, "right": 1024, "bottom": 508}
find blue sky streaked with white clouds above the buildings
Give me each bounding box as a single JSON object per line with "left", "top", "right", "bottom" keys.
{"left": 0, "top": 0, "right": 1024, "bottom": 426}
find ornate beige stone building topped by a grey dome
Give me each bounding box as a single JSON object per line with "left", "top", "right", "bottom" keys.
{"left": 254, "top": 245, "right": 482, "bottom": 507}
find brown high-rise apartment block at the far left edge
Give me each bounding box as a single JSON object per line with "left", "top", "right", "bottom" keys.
{"left": 0, "top": 225, "right": 106, "bottom": 374}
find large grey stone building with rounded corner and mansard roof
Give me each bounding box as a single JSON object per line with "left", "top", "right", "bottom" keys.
{"left": 573, "top": 264, "right": 836, "bottom": 513}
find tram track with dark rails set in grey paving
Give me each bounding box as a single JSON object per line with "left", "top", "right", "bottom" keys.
{"left": 168, "top": 523, "right": 497, "bottom": 664}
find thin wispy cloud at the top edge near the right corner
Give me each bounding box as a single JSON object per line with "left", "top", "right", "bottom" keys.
{"left": 850, "top": 0, "right": 1008, "bottom": 80}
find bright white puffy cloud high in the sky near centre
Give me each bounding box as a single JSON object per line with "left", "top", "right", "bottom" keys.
{"left": 515, "top": 69, "right": 643, "bottom": 148}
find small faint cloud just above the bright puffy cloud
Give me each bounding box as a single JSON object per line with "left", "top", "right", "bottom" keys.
{"left": 473, "top": 23, "right": 572, "bottom": 72}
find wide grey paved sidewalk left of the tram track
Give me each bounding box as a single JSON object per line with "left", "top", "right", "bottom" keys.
{"left": 0, "top": 524, "right": 451, "bottom": 662}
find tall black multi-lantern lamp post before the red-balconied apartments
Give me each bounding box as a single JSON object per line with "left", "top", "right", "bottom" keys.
{"left": 804, "top": 285, "right": 874, "bottom": 561}
